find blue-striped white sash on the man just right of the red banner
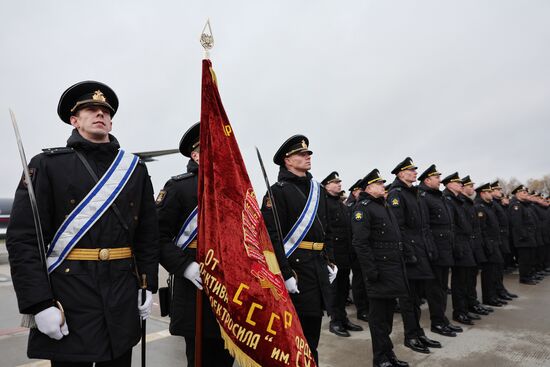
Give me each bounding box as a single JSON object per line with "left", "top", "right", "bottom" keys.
{"left": 283, "top": 180, "right": 321, "bottom": 257}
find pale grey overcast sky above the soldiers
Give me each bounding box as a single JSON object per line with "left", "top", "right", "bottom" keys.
{"left": 0, "top": 0, "right": 550, "bottom": 201}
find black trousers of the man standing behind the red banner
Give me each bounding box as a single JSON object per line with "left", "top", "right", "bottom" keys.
{"left": 185, "top": 336, "right": 234, "bottom": 367}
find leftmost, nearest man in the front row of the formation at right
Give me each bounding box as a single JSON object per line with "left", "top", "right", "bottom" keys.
{"left": 352, "top": 169, "right": 409, "bottom": 367}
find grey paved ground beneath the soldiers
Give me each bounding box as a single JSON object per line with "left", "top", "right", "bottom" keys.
{"left": 0, "top": 253, "right": 550, "bottom": 367}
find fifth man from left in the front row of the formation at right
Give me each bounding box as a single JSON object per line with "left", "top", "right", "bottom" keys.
{"left": 459, "top": 176, "right": 487, "bottom": 320}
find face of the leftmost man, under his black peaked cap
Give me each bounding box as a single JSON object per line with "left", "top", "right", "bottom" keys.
{"left": 71, "top": 106, "right": 113, "bottom": 143}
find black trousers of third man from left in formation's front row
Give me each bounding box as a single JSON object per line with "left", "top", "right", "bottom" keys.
{"left": 430, "top": 265, "right": 449, "bottom": 325}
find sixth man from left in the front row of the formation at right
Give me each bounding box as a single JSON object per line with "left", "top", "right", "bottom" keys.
{"left": 474, "top": 183, "right": 504, "bottom": 304}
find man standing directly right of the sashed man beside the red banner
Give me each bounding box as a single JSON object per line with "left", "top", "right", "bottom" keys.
{"left": 321, "top": 171, "right": 363, "bottom": 337}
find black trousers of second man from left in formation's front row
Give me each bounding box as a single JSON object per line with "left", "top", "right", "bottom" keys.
{"left": 402, "top": 279, "right": 426, "bottom": 339}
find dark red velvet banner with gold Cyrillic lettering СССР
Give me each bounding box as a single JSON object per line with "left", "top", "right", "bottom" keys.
{"left": 197, "top": 60, "right": 315, "bottom": 367}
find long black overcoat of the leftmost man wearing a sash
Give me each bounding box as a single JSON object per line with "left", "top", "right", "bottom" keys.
{"left": 6, "top": 130, "right": 159, "bottom": 362}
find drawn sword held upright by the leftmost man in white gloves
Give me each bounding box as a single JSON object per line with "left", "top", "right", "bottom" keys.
{"left": 10, "top": 109, "right": 65, "bottom": 328}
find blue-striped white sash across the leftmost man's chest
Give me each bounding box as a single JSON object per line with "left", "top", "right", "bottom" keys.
{"left": 46, "top": 149, "right": 139, "bottom": 273}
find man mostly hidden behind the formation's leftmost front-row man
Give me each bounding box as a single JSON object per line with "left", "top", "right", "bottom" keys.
{"left": 345, "top": 178, "right": 369, "bottom": 322}
